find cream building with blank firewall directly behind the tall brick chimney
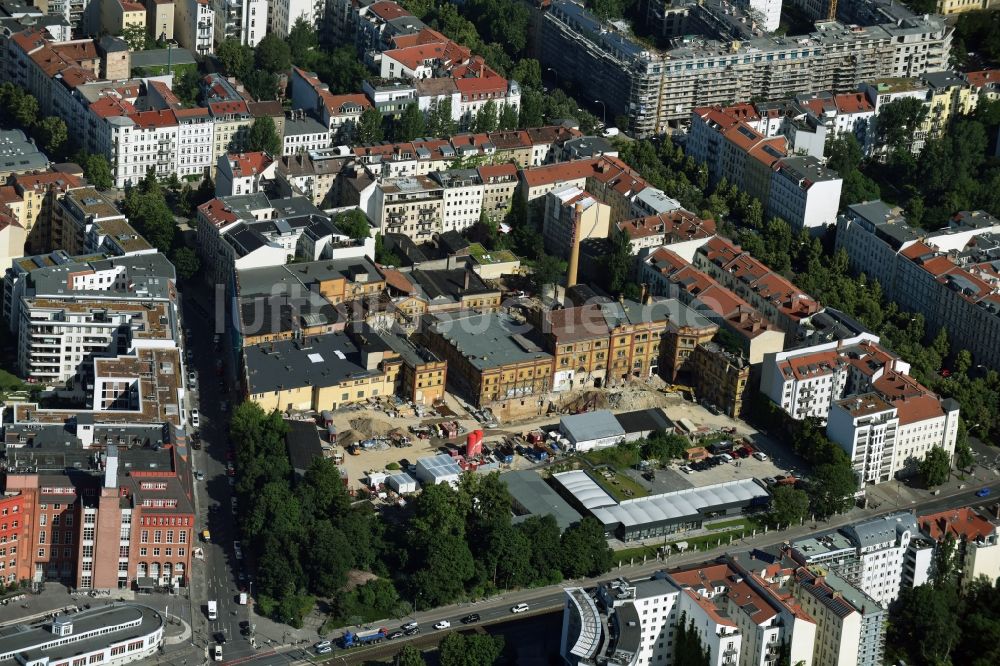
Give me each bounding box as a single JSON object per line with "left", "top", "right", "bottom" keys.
{"left": 542, "top": 185, "right": 611, "bottom": 259}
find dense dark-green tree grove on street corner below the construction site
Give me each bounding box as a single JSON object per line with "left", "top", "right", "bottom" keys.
{"left": 230, "top": 402, "right": 612, "bottom": 626}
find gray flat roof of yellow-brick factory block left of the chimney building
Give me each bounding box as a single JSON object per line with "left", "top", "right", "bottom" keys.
{"left": 432, "top": 312, "right": 552, "bottom": 370}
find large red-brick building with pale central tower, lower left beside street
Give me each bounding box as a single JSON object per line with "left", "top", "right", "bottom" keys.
{"left": 3, "top": 426, "right": 197, "bottom": 592}
